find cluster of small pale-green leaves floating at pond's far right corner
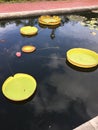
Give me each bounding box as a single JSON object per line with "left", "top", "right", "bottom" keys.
{"left": 81, "top": 18, "right": 98, "bottom": 30}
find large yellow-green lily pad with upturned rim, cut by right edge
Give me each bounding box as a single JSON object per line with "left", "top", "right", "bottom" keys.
{"left": 67, "top": 48, "right": 98, "bottom": 68}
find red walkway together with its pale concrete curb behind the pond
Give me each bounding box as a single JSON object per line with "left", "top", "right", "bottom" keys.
{"left": 0, "top": 0, "right": 98, "bottom": 19}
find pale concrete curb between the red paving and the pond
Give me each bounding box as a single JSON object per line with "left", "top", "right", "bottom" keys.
{"left": 0, "top": 6, "right": 98, "bottom": 20}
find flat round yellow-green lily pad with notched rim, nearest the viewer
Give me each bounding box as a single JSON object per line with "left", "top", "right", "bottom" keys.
{"left": 2, "top": 73, "right": 37, "bottom": 101}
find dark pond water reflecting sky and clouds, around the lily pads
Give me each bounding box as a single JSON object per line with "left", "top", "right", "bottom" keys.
{"left": 0, "top": 12, "right": 98, "bottom": 130}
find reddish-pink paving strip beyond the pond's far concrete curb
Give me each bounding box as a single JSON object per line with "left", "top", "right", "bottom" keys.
{"left": 0, "top": 0, "right": 98, "bottom": 14}
